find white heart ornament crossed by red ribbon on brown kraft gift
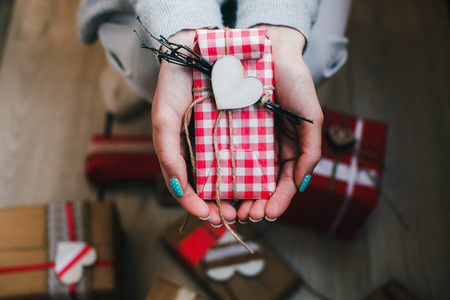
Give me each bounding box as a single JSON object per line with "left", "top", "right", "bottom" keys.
{"left": 55, "top": 242, "right": 97, "bottom": 285}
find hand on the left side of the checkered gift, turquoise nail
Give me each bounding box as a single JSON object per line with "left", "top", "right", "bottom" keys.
{"left": 152, "top": 30, "right": 236, "bottom": 225}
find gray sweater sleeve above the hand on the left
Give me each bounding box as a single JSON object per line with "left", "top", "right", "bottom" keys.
{"left": 77, "top": 0, "right": 223, "bottom": 44}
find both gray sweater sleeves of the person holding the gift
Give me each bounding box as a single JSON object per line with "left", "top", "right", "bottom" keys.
{"left": 77, "top": 0, "right": 320, "bottom": 44}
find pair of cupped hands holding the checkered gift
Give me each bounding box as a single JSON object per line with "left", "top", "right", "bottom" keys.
{"left": 152, "top": 25, "right": 323, "bottom": 225}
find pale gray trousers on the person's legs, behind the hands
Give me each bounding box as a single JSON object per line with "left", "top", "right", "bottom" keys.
{"left": 99, "top": 0, "right": 351, "bottom": 102}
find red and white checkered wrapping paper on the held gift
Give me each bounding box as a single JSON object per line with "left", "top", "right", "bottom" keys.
{"left": 193, "top": 29, "right": 276, "bottom": 199}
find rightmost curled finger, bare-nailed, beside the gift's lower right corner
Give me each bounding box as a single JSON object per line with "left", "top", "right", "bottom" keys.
{"left": 265, "top": 161, "right": 297, "bottom": 219}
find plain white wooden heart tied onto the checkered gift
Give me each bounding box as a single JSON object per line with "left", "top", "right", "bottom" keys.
{"left": 211, "top": 55, "right": 264, "bottom": 110}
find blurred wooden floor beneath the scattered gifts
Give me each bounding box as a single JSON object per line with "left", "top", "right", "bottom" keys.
{"left": 0, "top": 0, "right": 450, "bottom": 300}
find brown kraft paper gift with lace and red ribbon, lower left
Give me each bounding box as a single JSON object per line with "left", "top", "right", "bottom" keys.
{"left": 0, "top": 202, "right": 118, "bottom": 299}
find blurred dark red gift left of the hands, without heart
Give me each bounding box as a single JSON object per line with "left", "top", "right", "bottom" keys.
{"left": 85, "top": 135, "right": 161, "bottom": 184}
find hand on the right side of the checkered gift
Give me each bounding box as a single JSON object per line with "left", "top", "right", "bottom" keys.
{"left": 237, "top": 25, "right": 323, "bottom": 221}
